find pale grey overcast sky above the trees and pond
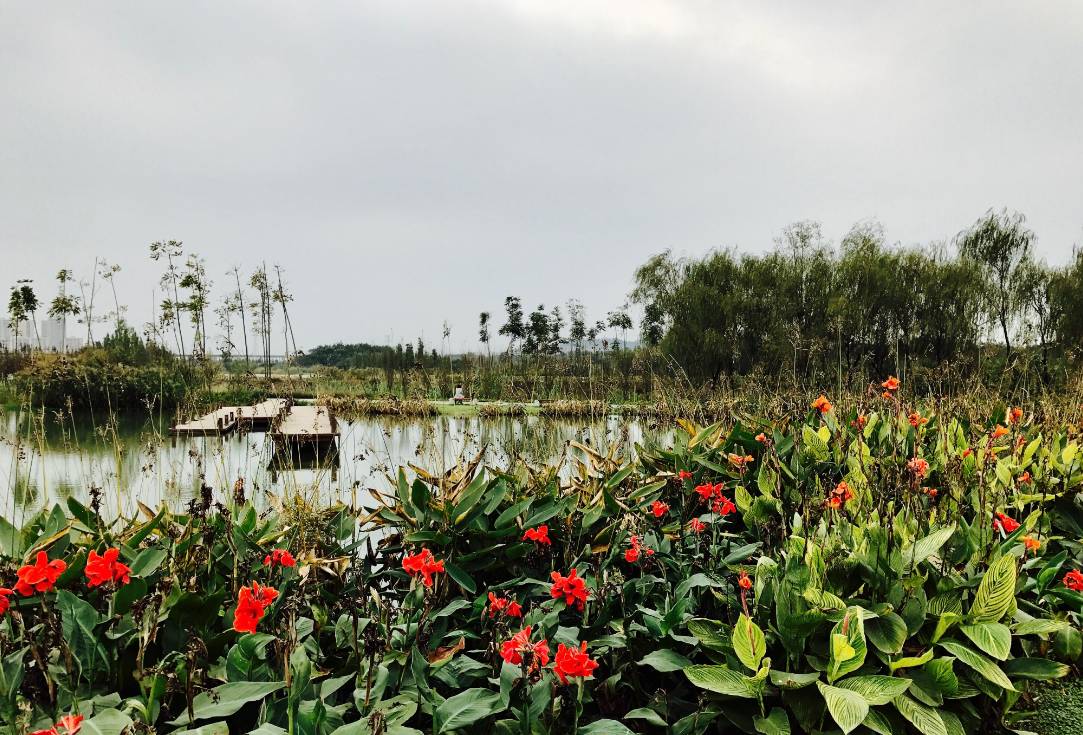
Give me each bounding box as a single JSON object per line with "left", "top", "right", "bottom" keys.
{"left": 0, "top": 0, "right": 1083, "bottom": 350}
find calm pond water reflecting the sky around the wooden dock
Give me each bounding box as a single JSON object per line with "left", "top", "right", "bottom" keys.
{"left": 0, "top": 411, "right": 673, "bottom": 526}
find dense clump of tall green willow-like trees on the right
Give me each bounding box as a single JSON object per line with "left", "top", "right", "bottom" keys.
{"left": 631, "top": 211, "right": 1083, "bottom": 381}
